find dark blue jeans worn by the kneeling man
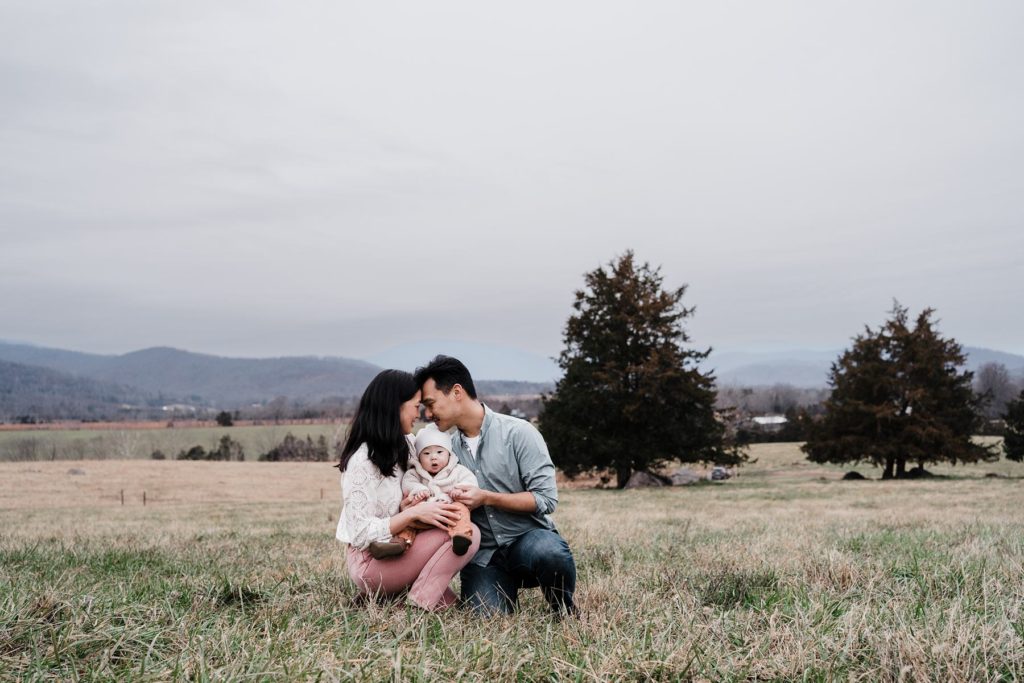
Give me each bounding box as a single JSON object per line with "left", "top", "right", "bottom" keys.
{"left": 460, "top": 528, "right": 577, "bottom": 613}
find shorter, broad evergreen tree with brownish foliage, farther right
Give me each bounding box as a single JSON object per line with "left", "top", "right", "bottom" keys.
{"left": 803, "top": 302, "right": 993, "bottom": 478}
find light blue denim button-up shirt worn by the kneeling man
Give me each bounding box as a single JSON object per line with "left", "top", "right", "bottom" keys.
{"left": 452, "top": 405, "right": 558, "bottom": 566}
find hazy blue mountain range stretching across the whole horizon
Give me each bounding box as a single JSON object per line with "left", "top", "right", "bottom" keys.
{"left": 0, "top": 342, "right": 1024, "bottom": 419}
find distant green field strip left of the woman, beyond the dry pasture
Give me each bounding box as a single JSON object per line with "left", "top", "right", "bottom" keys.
{"left": 0, "top": 423, "right": 344, "bottom": 462}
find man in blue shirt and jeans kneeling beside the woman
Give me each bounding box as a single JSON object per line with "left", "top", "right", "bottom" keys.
{"left": 416, "top": 355, "right": 577, "bottom": 615}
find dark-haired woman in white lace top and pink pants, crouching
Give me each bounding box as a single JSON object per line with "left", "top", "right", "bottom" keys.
{"left": 337, "top": 370, "right": 480, "bottom": 610}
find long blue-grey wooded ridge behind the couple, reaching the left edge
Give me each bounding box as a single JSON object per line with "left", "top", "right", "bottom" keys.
{"left": 0, "top": 342, "right": 551, "bottom": 408}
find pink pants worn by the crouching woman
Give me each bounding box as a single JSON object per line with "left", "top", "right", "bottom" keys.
{"left": 347, "top": 524, "right": 480, "bottom": 609}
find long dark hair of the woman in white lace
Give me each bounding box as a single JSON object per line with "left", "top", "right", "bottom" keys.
{"left": 338, "top": 370, "right": 420, "bottom": 476}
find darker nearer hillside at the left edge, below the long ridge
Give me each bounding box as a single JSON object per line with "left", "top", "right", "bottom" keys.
{"left": 0, "top": 360, "right": 153, "bottom": 422}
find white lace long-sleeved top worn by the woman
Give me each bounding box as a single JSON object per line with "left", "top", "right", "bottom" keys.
{"left": 335, "top": 443, "right": 412, "bottom": 550}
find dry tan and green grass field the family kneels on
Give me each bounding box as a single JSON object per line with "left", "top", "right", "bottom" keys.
{"left": 0, "top": 444, "right": 1024, "bottom": 681}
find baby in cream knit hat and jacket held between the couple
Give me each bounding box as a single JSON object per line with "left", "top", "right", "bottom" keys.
{"left": 369, "top": 425, "right": 479, "bottom": 559}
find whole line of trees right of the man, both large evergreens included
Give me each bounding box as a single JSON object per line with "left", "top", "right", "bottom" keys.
{"left": 540, "top": 251, "right": 1024, "bottom": 487}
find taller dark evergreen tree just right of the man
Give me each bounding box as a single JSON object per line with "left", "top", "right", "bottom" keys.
{"left": 541, "top": 251, "right": 745, "bottom": 487}
